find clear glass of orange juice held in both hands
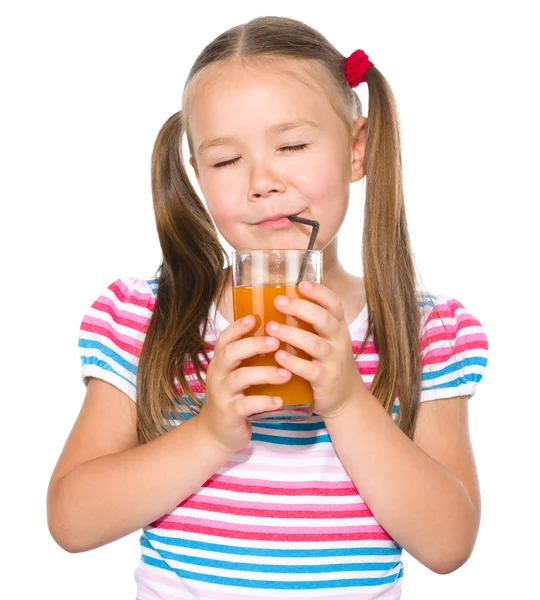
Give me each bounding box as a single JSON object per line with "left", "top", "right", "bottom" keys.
{"left": 232, "top": 249, "right": 323, "bottom": 422}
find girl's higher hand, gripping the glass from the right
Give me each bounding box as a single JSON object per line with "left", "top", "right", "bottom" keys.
{"left": 266, "top": 282, "right": 365, "bottom": 419}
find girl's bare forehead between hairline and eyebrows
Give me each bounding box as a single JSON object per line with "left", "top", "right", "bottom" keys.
{"left": 189, "top": 64, "right": 333, "bottom": 148}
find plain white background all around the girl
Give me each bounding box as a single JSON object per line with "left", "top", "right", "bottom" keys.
{"left": 0, "top": 0, "right": 540, "bottom": 600}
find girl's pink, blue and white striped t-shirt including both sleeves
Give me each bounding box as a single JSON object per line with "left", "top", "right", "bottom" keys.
{"left": 79, "top": 277, "right": 488, "bottom": 600}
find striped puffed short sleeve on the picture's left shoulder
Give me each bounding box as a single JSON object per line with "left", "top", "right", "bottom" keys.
{"left": 79, "top": 277, "right": 157, "bottom": 401}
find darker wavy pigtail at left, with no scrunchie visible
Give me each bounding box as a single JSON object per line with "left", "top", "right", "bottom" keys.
{"left": 137, "top": 111, "right": 228, "bottom": 442}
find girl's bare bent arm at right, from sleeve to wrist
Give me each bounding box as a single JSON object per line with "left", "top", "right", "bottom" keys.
{"left": 325, "top": 388, "right": 480, "bottom": 574}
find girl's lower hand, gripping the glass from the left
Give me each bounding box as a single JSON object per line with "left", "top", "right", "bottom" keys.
{"left": 198, "top": 315, "right": 291, "bottom": 454}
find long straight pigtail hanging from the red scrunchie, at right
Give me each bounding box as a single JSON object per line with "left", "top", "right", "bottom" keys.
{"left": 362, "top": 67, "right": 422, "bottom": 437}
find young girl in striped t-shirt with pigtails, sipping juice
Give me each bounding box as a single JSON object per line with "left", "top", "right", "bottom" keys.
{"left": 48, "top": 17, "right": 488, "bottom": 600}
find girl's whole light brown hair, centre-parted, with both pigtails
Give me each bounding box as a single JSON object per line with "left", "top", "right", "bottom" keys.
{"left": 137, "top": 16, "right": 422, "bottom": 443}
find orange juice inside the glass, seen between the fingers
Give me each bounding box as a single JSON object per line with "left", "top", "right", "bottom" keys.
{"left": 233, "top": 283, "right": 315, "bottom": 406}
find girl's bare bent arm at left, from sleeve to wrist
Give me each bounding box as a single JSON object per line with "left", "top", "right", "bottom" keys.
{"left": 47, "top": 378, "right": 230, "bottom": 552}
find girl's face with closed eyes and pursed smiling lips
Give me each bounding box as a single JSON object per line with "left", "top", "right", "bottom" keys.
{"left": 190, "top": 63, "right": 365, "bottom": 250}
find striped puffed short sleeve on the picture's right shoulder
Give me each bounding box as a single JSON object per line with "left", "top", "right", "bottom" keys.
{"left": 420, "top": 294, "right": 488, "bottom": 402}
